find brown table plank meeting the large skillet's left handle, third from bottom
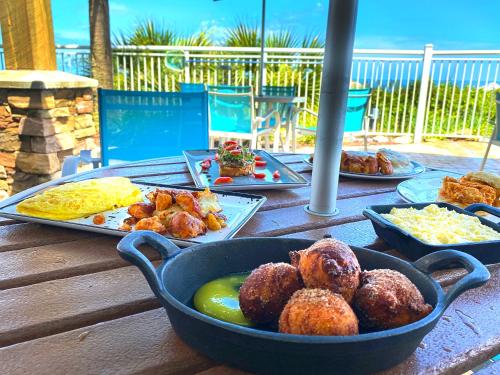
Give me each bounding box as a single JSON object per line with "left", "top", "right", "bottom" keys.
{"left": 0, "top": 236, "right": 160, "bottom": 290}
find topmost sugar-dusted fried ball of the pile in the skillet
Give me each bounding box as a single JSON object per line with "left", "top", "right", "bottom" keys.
{"left": 290, "top": 238, "right": 361, "bottom": 304}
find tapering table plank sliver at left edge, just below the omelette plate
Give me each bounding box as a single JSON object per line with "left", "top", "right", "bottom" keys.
{"left": 0, "top": 223, "right": 94, "bottom": 252}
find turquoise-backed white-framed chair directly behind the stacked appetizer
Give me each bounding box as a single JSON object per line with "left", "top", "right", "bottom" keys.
{"left": 208, "top": 91, "right": 281, "bottom": 152}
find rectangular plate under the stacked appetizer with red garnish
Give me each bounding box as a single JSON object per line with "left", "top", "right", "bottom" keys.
{"left": 184, "top": 150, "right": 309, "bottom": 190}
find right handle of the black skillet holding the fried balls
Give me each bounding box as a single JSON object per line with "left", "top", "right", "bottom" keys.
{"left": 413, "top": 250, "right": 490, "bottom": 309}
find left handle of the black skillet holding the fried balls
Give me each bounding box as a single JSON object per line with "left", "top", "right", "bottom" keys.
{"left": 116, "top": 230, "right": 181, "bottom": 299}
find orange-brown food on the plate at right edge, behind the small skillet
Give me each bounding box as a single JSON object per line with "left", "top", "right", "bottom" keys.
{"left": 438, "top": 172, "right": 500, "bottom": 207}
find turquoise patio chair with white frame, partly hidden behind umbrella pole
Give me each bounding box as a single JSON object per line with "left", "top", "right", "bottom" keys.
{"left": 292, "top": 88, "right": 378, "bottom": 152}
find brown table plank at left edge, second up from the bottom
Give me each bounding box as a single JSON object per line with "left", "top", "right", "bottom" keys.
{"left": 0, "top": 267, "right": 159, "bottom": 346}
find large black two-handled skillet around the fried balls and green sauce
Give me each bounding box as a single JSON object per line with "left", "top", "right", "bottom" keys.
{"left": 118, "top": 231, "right": 490, "bottom": 374}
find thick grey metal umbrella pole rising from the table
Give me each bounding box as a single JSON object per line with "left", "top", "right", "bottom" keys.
{"left": 305, "top": 0, "right": 358, "bottom": 216}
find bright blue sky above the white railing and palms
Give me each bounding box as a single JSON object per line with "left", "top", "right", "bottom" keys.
{"left": 45, "top": 0, "right": 500, "bottom": 49}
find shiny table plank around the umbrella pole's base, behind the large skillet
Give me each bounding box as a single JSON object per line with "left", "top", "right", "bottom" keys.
{"left": 238, "top": 192, "right": 400, "bottom": 237}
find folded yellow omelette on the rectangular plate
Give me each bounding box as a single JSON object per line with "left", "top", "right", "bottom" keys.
{"left": 16, "top": 177, "right": 142, "bottom": 220}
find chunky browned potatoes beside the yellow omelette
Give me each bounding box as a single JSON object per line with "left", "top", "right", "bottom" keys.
{"left": 124, "top": 188, "right": 226, "bottom": 239}
